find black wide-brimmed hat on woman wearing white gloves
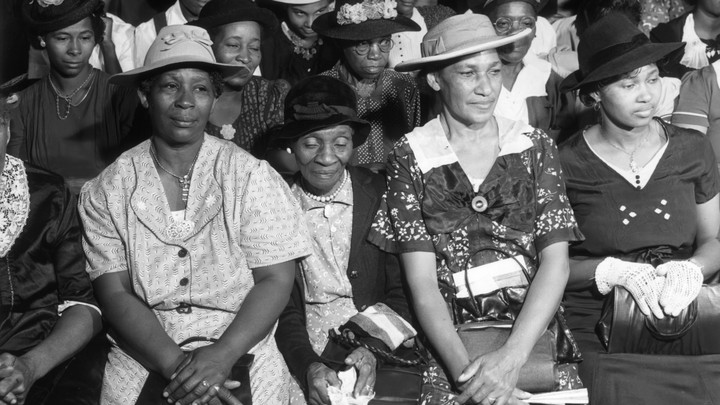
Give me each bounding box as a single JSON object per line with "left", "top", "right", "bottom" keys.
{"left": 561, "top": 13, "right": 685, "bottom": 91}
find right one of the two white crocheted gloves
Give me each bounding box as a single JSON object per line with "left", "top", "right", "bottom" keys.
{"left": 657, "top": 260, "right": 703, "bottom": 316}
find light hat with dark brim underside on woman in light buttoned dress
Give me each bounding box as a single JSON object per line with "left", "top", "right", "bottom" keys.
{"left": 110, "top": 25, "right": 245, "bottom": 85}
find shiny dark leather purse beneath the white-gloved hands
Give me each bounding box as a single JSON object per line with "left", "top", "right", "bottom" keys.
{"left": 596, "top": 284, "right": 720, "bottom": 356}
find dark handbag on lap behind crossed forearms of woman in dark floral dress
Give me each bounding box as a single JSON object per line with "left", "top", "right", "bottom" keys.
{"left": 453, "top": 249, "right": 582, "bottom": 392}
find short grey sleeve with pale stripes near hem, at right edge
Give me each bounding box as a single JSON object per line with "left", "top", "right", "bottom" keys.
{"left": 672, "top": 66, "right": 718, "bottom": 128}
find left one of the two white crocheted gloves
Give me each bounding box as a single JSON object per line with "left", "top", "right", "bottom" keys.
{"left": 595, "top": 257, "right": 664, "bottom": 319}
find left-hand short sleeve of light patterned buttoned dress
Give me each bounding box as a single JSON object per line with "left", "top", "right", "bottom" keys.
{"left": 79, "top": 176, "right": 128, "bottom": 281}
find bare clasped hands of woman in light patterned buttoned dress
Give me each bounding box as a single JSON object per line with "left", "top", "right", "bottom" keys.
{"left": 163, "top": 344, "right": 242, "bottom": 405}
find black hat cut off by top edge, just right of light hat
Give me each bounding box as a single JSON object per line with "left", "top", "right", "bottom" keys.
{"left": 188, "top": 0, "right": 278, "bottom": 32}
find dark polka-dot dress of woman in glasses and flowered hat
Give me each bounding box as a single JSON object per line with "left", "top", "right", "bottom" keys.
{"left": 322, "top": 61, "right": 422, "bottom": 165}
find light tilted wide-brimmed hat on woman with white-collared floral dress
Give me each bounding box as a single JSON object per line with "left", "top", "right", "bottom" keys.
{"left": 395, "top": 13, "right": 532, "bottom": 72}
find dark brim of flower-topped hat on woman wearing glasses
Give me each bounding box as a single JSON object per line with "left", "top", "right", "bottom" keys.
{"left": 312, "top": 13, "right": 420, "bottom": 41}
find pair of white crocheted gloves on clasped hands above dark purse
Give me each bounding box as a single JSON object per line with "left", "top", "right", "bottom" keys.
{"left": 595, "top": 257, "right": 703, "bottom": 319}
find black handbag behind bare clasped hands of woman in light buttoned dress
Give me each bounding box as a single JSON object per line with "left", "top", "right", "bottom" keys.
{"left": 135, "top": 337, "right": 255, "bottom": 405}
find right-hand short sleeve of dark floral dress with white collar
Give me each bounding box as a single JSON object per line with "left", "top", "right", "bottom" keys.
{"left": 530, "top": 130, "right": 583, "bottom": 252}
